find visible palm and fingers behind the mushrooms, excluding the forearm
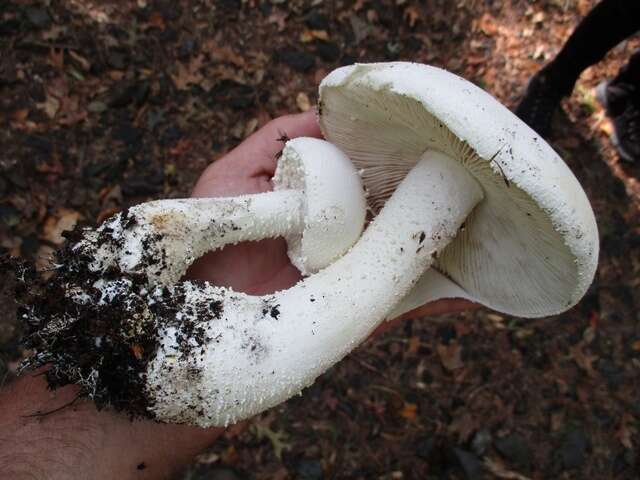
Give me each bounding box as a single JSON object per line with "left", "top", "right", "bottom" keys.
{"left": 188, "top": 112, "right": 475, "bottom": 326}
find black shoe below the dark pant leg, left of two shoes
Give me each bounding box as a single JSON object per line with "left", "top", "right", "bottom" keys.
{"left": 515, "top": 71, "right": 564, "bottom": 138}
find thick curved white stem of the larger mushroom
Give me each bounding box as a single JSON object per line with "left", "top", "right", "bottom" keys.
{"left": 147, "top": 151, "right": 483, "bottom": 426}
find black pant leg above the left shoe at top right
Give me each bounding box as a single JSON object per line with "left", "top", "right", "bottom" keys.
{"left": 544, "top": 0, "right": 640, "bottom": 95}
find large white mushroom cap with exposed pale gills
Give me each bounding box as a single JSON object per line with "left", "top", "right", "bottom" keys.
{"left": 319, "top": 62, "right": 599, "bottom": 317}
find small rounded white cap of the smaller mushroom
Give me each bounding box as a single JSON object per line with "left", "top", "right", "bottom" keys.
{"left": 273, "top": 137, "right": 367, "bottom": 275}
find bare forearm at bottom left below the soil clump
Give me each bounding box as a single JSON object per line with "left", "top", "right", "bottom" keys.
{"left": 0, "top": 374, "right": 223, "bottom": 480}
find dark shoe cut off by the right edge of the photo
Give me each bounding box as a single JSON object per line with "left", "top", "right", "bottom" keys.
{"left": 596, "top": 78, "right": 640, "bottom": 162}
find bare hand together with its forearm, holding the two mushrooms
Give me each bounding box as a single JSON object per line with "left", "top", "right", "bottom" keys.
{"left": 0, "top": 112, "right": 473, "bottom": 479}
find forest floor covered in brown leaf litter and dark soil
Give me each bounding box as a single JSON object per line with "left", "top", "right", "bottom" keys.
{"left": 0, "top": 0, "right": 640, "bottom": 480}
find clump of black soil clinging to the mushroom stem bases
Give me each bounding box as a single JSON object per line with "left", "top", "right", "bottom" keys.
{"left": 4, "top": 223, "right": 208, "bottom": 417}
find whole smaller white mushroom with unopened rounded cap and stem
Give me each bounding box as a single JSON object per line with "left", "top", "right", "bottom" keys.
{"left": 75, "top": 138, "right": 366, "bottom": 284}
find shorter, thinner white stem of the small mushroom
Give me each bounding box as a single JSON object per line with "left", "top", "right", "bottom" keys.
{"left": 84, "top": 190, "right": 304, "bottom": 285}
